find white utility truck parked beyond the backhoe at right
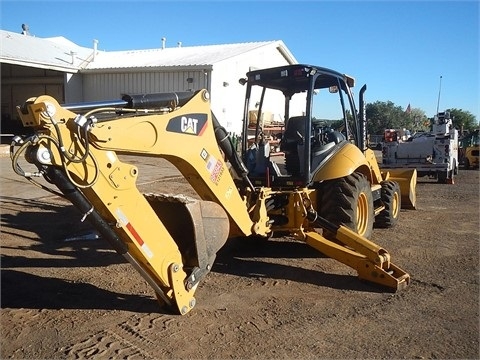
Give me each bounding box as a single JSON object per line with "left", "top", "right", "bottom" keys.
{"left": 381, "top": 111, "right": 458, "bottom": 184}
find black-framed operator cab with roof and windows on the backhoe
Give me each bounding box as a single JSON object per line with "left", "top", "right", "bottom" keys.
{"left": 240, "top": 64, "right": 360, "bottom": 187}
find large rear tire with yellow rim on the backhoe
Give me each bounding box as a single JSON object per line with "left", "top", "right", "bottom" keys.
{"left": 319, "top": 172, "right": 374, "bottom": 238}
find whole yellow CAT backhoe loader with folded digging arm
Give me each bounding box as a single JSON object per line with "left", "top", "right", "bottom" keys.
{"left": 10, "top": 65, "right": 415, "bottom": 314}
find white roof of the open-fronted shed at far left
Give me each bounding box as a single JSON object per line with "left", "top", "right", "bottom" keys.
{"left": 0, "top": 30, "right": 93, "bottom": 73}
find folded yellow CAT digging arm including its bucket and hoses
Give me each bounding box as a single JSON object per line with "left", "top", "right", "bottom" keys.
{"left": 12, "top": 93, "right": 253, "bottom": 314}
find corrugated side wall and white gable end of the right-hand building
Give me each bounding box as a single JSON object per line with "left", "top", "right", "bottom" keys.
{"left": 77, "top": 44, "right": 294, "bottom": 134}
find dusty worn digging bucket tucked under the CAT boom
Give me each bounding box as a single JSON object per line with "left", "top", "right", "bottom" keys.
{"left": 144, "top": 194, "right": 230, "bottom": 269}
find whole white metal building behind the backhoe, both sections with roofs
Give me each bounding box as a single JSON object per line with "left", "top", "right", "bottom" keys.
{"left": 0, "top": 30, "right": 297, "bottom": 133}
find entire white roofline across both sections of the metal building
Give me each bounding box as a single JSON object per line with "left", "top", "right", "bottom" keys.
{"left": 0, "top": 30, "right": 297, "bottom": 72}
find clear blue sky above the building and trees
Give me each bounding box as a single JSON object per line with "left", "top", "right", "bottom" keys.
{"left": 0, "top": 0, "right": 480, "bottom": 121}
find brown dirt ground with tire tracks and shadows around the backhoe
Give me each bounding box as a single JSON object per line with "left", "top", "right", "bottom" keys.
{"left": 0, "top": 153, "right": 480, "bottom": 359}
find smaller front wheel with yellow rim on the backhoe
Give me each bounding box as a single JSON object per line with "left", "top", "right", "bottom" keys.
{"left": 375, "top": 180, "right": 402, "bottom": 228}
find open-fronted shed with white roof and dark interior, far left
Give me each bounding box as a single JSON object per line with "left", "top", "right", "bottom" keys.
{"left": 0, "top": 30, "right": 93, "bottom": 134}
